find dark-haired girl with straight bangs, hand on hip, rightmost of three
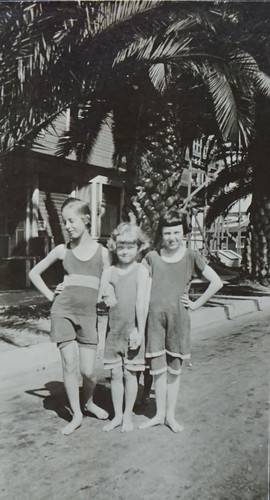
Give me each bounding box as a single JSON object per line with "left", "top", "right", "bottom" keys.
{"left": 140, "top": 211, "right": 222, "bottom": 432}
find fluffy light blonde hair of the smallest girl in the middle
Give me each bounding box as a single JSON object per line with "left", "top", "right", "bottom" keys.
{"left": 107, "top": 222, "right": 150, "bottom": 252}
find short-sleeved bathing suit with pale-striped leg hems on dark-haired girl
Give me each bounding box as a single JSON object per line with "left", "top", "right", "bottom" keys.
{"left": 144, "top": 249, "right": 205, "bottom": 374}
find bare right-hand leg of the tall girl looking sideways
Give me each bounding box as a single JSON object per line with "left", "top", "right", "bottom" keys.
{"left": 79, "top": 345, "right": 109, "bottom": 420}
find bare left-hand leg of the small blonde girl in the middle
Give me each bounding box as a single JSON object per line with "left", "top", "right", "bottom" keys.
{"left": 103, "top": 366, "right": 124, "bottom": 432}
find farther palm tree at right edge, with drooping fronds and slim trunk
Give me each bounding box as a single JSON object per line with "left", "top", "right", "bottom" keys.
{"left": 205, "top": 94, "right": 270, "bottom": 286}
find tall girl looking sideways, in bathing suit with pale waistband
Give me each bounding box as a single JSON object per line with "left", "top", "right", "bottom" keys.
{"left": 29, "top": 198, "right": 110, "bottom": 435}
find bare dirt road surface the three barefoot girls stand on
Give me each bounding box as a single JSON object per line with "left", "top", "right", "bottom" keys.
{"left": 0, "top": 312, "right": 270, "bottom": 500}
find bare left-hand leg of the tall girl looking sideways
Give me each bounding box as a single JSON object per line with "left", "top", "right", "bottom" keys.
{"left": 60, "top": 341, "right": 82, "bottom": 435}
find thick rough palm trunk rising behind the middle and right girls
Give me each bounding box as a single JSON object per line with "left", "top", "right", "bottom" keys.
{"left": 121, "top": 108, "right": 185, "bottom": 238}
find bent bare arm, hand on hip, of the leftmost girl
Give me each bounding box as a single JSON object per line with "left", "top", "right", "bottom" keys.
{"left": 29, "top": 245, "right": 65, "bottom": 302}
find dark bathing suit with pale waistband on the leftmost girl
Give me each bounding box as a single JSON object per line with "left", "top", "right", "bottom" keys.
{"left": 51, "top": 245, "right": 103, "bottom": 348}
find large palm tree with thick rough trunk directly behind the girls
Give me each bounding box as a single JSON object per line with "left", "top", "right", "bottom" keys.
{"left": 51, "top": 2, "right": 270, "bottom": 237}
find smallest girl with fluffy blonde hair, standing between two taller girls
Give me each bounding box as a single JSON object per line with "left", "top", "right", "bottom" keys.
{"left": 99, "top": 222, "right": 149, "bottom": 432}
